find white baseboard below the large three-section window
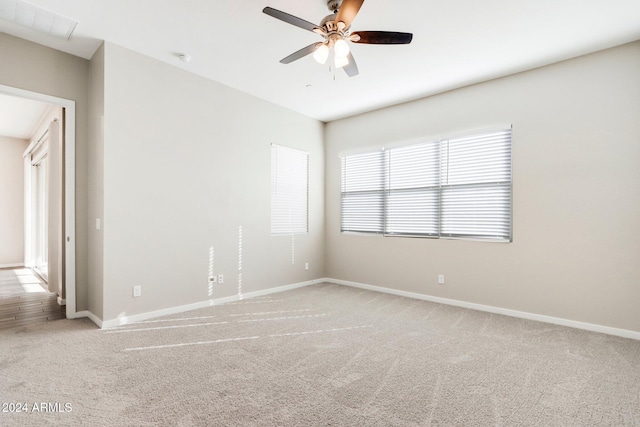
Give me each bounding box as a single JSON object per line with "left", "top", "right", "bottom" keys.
{"left": 325, "top": 278, "right": 640, "bottom": 340}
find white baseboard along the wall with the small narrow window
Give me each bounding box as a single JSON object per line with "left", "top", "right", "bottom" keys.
{"left": 101, "top": 279, "right": 326, "bottom": 329}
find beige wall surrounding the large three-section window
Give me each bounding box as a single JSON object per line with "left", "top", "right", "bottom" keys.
{"left": 326, "top": 42, "right": 640, "bottom": 331}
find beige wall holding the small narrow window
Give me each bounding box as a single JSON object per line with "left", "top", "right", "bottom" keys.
{"left": 102, "top": 43, "right": 325, "bottom": 320}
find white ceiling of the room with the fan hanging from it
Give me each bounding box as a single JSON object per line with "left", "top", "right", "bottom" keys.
{"left": 0, "top": 0, "right": 640, "bottom": 121}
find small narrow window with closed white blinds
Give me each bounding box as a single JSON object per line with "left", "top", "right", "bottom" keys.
{"left": 271, "top": 144, "right": 309, "bottom": 235}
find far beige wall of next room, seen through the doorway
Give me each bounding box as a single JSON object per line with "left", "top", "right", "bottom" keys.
{"left": 0, "top": 136, "right": 29, "bottom": 268}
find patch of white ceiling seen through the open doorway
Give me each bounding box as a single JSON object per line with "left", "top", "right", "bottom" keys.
{"left": 0, "top": 93, "right": 50, "bottom": 139}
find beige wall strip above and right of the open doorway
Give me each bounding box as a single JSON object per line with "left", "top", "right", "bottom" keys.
{"left": 0, "top": 33, "right": 89, "bottom": 311}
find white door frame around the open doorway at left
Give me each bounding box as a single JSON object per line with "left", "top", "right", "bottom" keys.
{"left": 0, "top": 85, "right": 78, "bottom": 319}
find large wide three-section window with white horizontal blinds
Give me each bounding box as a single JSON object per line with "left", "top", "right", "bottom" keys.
{"left": 341, "top": 129, "right": 511, "bottom": 241}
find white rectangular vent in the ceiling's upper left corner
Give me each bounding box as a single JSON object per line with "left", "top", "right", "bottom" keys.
{"left": 0, "top": 0, "right": 78, "bottom": 40}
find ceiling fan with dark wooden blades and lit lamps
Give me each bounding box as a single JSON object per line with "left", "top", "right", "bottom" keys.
{"left": 262, "top": 0, "right": 413, "bottom": 77}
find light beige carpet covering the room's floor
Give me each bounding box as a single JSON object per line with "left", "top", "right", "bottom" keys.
{"left": 0, "top": 284, "right": 640, "bottom": 426}
